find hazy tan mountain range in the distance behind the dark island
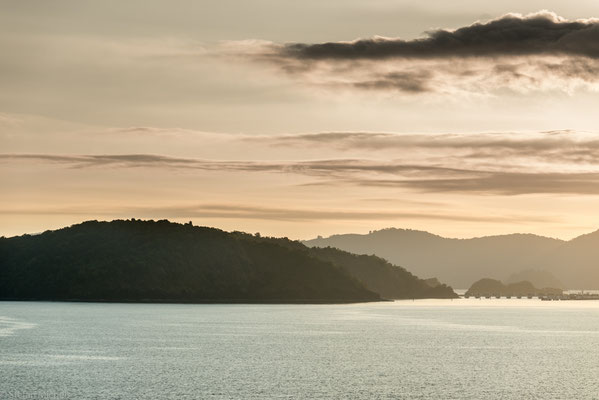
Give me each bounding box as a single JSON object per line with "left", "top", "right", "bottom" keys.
{"left": 303, "top": 228, "right": 599, "bottom": 289}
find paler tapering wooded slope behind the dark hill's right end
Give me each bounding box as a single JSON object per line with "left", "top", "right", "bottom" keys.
{"left": 310, "top": 247, "right": 458, "bottom": 299}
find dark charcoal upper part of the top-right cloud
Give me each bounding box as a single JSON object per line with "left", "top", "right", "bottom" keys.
{"left": 279, "top": 11, "right": 599, "bottom": 60}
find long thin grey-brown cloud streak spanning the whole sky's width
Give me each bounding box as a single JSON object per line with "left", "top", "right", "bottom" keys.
{"left": 0, "top": 151, "right": 599, "bottom": 196}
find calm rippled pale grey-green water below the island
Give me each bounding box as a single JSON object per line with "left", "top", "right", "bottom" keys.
{"left": 0, "top": 299, "right": 599, "bottom": 399}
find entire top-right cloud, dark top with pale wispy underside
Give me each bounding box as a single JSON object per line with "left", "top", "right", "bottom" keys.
{"left": 237, "top": 11, "right": 599, "bottom": 95}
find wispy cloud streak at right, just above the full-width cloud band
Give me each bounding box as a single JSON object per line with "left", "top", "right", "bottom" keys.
{"left": 251, "top": 130, "right": 599, "bottom": 168}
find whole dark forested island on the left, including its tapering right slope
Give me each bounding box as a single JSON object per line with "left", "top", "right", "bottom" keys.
{"left": 0, "top": 219, "right": 457, "bottom": 303}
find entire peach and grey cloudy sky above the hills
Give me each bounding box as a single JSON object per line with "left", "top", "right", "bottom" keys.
{"left": 0, "top": 0, "right": 599, "bottom": 239}
